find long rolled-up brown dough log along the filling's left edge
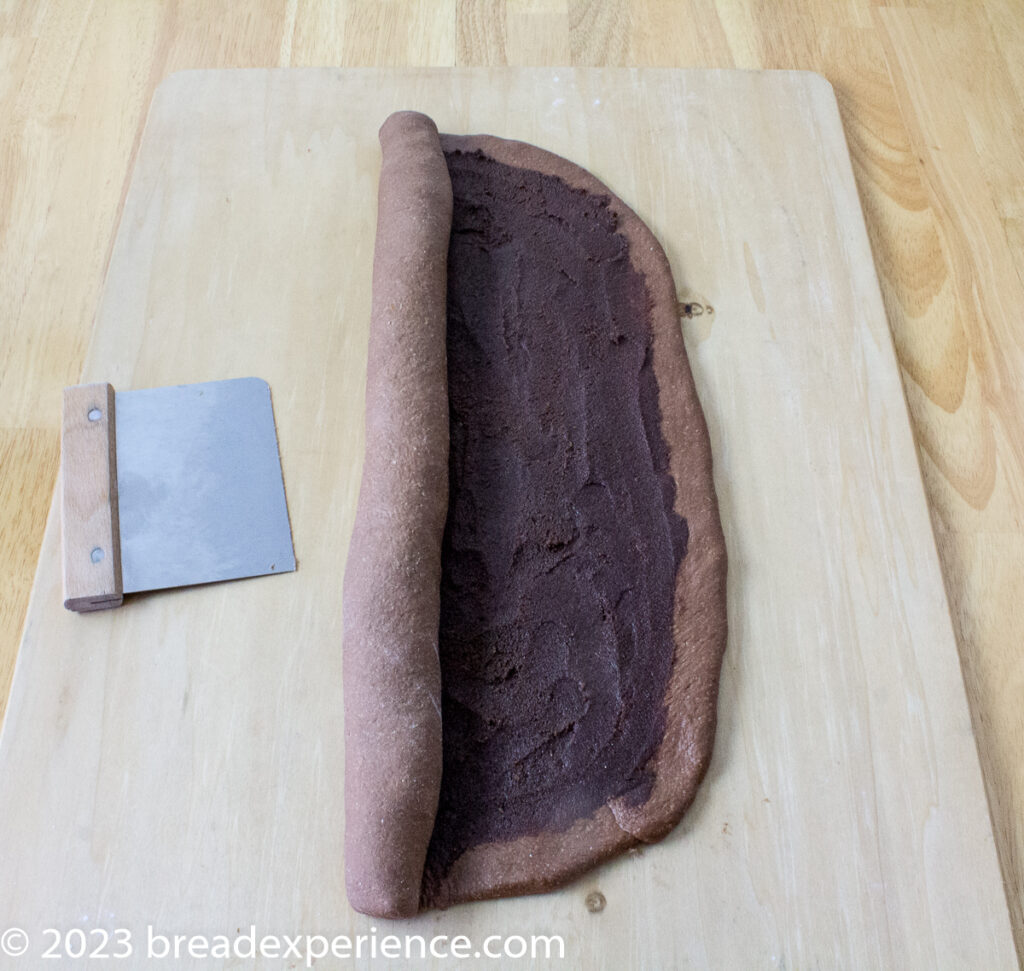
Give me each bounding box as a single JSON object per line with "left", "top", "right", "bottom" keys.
{"left": 342, "top": 112, "right": 452, "bottom": 917}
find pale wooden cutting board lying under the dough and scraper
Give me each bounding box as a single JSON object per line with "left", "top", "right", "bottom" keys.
{"left": 0, "top": 69, "right": 1015, "bottom": 969}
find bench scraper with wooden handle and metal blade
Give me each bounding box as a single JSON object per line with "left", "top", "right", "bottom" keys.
{"left": 60, "top": 378, "right": 295, "bottom": 610}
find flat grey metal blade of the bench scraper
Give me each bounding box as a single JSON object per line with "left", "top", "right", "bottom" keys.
{"left": 115, "top": 378, "right": 295, "bottom": 593}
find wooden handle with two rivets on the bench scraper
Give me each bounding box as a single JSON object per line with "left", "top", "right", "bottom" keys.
{"left": 60, "top": 384, "right": 124, "bottom": 611}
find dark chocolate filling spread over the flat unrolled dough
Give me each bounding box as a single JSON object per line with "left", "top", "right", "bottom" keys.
{"left": 425, "top": 152, "right": 688, "bottom": 882}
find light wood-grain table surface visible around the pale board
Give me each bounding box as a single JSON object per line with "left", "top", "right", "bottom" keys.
{"left": 0, "top": 0, "right": 1024, "bottom": 953}
